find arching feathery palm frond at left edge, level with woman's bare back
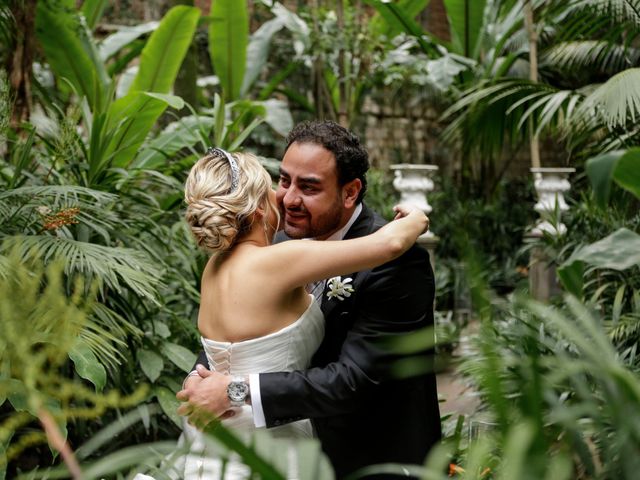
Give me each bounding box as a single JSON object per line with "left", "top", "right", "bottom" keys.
{"left": 0, "top": 235, "right": 161, "bottom": 304}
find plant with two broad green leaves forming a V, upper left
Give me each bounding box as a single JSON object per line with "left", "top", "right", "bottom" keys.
{"left": 31, "top": 2, "right": 200, "bottom": 186}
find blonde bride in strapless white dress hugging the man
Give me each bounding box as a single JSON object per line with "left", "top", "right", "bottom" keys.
{"left": 136, "top": 148, "right": 428, "bottom": 480}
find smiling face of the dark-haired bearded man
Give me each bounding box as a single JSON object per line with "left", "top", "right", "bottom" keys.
{"left": 276, "top": 143, "right": 352, "bottom": 240}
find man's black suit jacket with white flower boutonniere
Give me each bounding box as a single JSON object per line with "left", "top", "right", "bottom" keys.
{"left": 260, "top": 205, "right": 441, "bottom": 478}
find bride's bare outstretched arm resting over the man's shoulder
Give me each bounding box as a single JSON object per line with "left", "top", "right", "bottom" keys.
{"left": 254, "top": 205, "right": 429, "bottom": 289}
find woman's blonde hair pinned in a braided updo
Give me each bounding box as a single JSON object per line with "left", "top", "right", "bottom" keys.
{"left": 184, "top": 153, "right": 280, "bottom": 255}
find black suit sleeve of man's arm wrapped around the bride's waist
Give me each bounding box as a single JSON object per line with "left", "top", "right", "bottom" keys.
{"left": 260, "top": 247, "right": 434, "bottom": 426}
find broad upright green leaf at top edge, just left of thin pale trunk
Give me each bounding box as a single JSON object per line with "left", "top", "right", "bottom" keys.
{"left": 444, "top": 0, "right": 487, "bottom": 58}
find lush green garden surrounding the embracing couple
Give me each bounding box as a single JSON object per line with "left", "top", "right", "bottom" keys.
{"left": 0, "top": 0, "right": 640, "bottom": 480}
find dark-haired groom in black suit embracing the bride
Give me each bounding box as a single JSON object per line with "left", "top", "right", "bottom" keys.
{"left": 178, "top": 121, "right": 441, "bottom": 478}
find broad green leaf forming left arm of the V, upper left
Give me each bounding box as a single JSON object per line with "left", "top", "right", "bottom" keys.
{"left": 36, "top": 0, "right": 108, "bottom": 111}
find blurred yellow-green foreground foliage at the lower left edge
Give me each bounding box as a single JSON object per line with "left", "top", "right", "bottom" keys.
{"left": 0, "top": 251, "right": 145, "bottom": 476}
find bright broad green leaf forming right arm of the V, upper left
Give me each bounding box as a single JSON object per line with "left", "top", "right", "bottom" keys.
{"left": 129, "top": 2, "right": 200, "bottom": 93}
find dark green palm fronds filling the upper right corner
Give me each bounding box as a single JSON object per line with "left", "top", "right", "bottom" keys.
{"left": 448, "top": 0, "right": 639, "bottom": 174}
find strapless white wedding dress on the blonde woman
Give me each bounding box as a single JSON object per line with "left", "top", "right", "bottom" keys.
{"left": 134, "top": 300, "right": 324, "bottom": 480}
